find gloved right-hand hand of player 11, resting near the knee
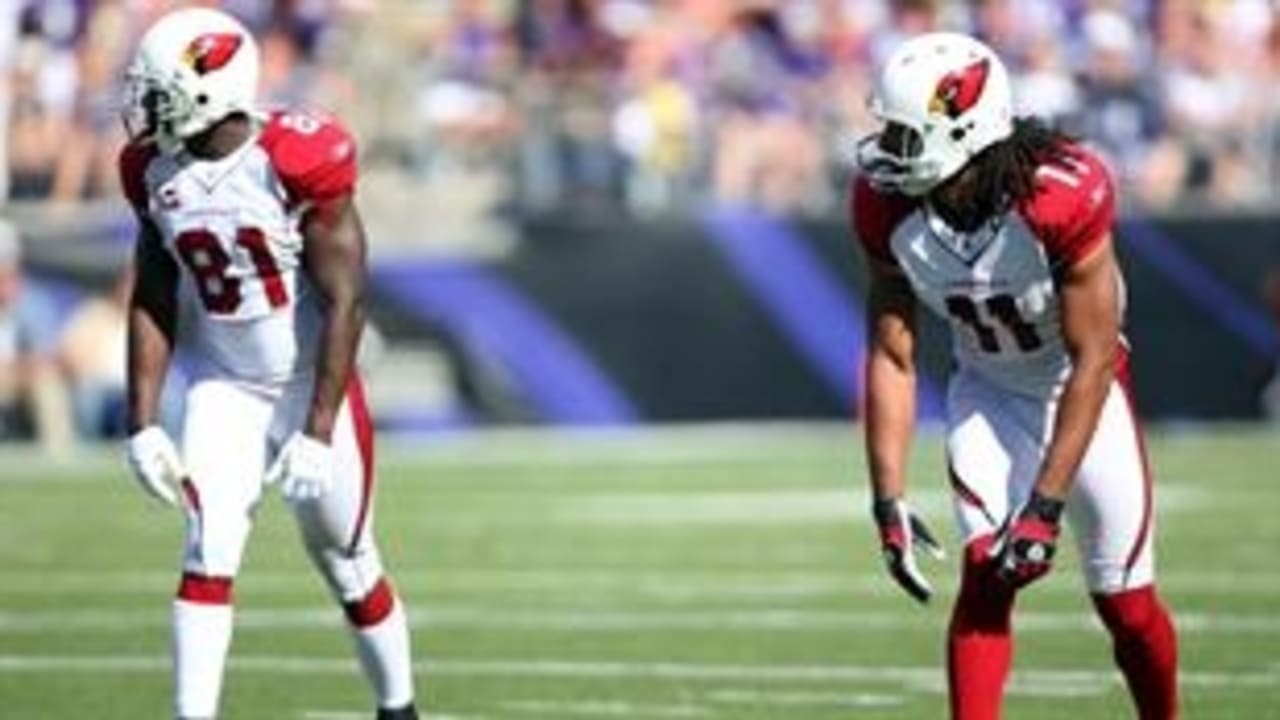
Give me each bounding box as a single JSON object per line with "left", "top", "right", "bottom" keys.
{"left": 991, "top": 492, "right": 1064, "bottom": 588}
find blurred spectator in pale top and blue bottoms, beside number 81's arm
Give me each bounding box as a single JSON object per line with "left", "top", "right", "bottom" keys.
{"left": 58, "top": 264, "right": 133, "bottom": 439}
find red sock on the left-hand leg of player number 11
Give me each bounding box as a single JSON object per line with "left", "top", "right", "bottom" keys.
{"left": 947, "top": 537, "right": 1014, "bottom": 720}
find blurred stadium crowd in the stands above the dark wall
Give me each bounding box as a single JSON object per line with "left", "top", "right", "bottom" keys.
{"left": 0, "top": 0, "right": 1280, "bottom": 214}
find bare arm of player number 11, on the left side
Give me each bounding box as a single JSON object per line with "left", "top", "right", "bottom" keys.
{"left": 865, "top": 261, "right": 916, "bottom": 500}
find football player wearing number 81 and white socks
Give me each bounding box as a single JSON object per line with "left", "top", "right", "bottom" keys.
{"left": 120, "top": 8, "right": 417, "bottom": 720}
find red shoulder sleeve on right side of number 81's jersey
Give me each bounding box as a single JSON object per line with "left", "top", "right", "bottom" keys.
{"left": 259, "top": 110, "right": 356, "bottom": 204}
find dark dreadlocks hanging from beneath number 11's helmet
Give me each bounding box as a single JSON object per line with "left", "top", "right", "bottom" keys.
{"left": 972, "top": 117, "right": 1079, "bottom": 210}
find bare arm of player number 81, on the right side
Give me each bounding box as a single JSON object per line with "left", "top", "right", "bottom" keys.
{"left": 302, "top": 193, "right": 366, "bottom": 442}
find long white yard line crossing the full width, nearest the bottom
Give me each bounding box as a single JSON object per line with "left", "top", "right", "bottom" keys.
{"left": 0, "top": 653, "right": 1280, "bottom": 694}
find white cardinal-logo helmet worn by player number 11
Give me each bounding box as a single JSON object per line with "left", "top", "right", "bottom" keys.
{"left": 858, "top": 32, "right": 1014, "bottom": 196}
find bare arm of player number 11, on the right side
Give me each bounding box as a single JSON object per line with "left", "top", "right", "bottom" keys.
{"left": 1036, "top": 237, "right": 1120, "bottom": 500}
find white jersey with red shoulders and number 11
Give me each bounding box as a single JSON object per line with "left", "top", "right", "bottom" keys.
{"left": 851, "top": 150, "right": 1123, "bottom": 398}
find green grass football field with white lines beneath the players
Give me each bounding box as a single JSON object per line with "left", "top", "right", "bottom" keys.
{"left": 0, "top": 425, "right": 1280, "bottom": 720}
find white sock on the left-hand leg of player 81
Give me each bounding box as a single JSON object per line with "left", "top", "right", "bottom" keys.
{"left": 173, "top": 600, "right": 232, "bottom": 719}
